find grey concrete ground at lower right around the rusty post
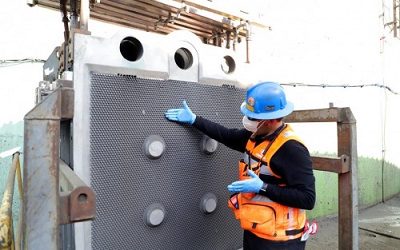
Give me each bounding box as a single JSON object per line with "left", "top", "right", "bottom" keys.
{"left": 306, "top": 195, "right": 400, "bottom": 250}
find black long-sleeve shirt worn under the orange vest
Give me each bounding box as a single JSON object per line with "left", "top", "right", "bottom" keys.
{"left": 193, "top": 116, "right": 315, "bottom": 209}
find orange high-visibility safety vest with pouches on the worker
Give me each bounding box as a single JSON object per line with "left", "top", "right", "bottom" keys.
{"left": 228, "top": 124, "right": 306, "bottom": 241}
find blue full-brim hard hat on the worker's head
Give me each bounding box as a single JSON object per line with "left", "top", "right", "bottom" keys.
{"left": 240, "top": 82, "right": 293, "bottom": 120}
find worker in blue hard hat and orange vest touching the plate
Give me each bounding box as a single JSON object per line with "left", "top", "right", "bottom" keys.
{"left": 165, "top": 82, "right": 315, "bottom": 250}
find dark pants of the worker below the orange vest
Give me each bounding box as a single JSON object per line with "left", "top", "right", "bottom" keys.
{"left": 243, "top": 230, "right": 306, "bottom": 250}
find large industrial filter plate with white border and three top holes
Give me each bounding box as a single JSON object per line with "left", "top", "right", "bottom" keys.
{"left": 73, "top": 31, "right": 244, "bottom": 249}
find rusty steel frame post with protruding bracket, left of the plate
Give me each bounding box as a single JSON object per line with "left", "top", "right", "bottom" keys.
{"left": 23, "top": 88, "right": 94, "bottom": 249}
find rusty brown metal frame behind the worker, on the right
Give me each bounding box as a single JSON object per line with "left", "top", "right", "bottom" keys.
{"left": 285, "top": 108, "right": 358, "bottom": 249}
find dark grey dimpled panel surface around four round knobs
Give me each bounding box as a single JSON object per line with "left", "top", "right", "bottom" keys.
{"left": 88, "top": 72, "right": 244, "bottom": 250}
